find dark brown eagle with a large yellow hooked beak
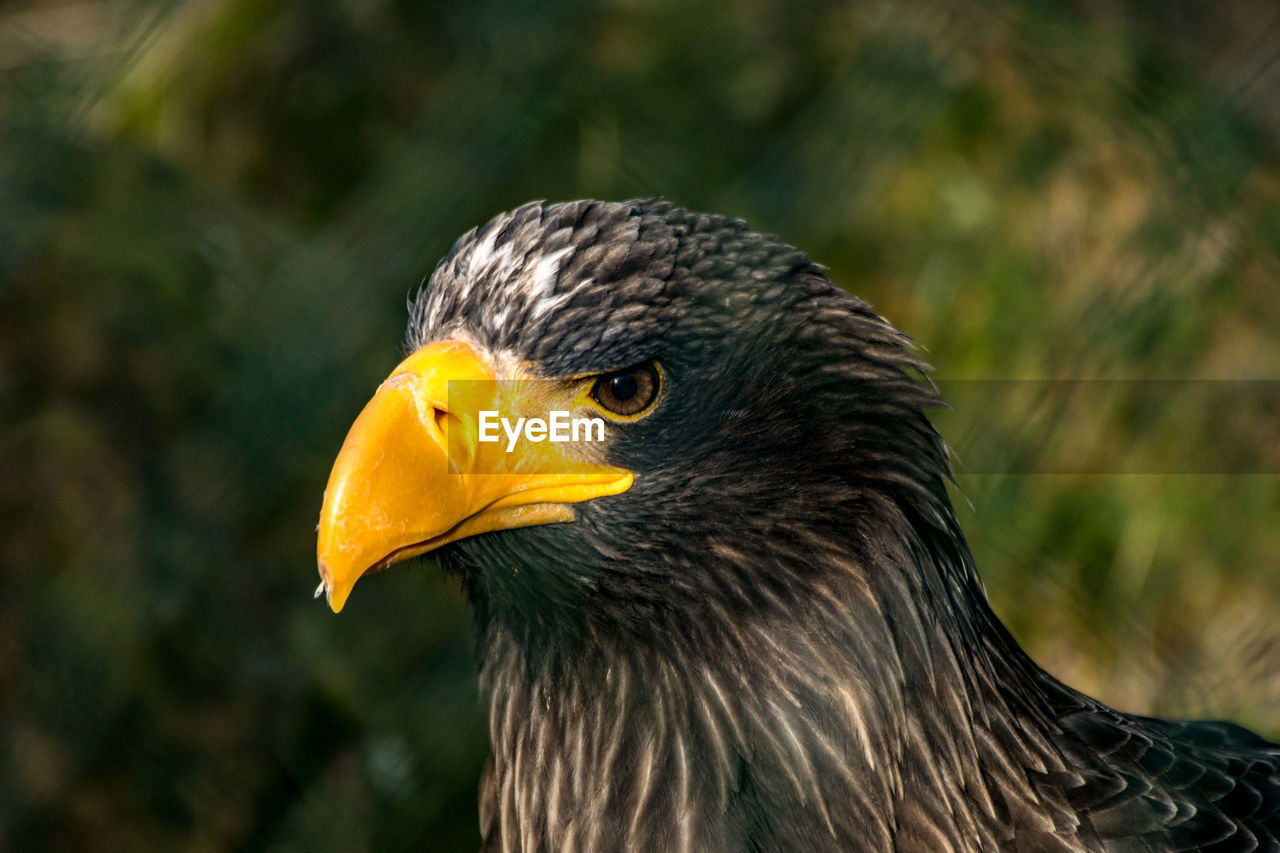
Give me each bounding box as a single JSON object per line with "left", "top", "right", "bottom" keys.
{"left": 317, "top": 199, "right": 1280, "bottom": 853}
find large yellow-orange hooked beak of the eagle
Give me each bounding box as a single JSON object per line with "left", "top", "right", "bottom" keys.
{"left": 316, "top": 341, "right": 632, "bottom": 612}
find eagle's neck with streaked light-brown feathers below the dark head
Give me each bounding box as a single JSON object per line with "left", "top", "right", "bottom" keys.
{"left": 471, "top": 502, "right": 1090, "bottom": 850}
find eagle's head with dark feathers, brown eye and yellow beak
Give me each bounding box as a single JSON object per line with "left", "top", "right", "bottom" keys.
{"left": 319, "top": 200, "right": 950, "bottom": 638}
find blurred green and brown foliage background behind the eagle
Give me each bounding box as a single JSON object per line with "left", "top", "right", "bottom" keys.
{"left": 0, "top": 0, "right": 1280, "bottom": 850}
